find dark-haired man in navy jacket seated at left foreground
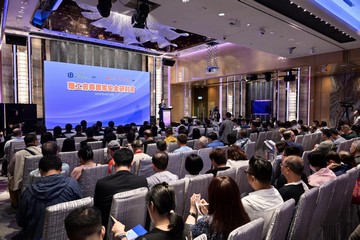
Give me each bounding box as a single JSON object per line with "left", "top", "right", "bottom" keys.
{"left": 16, "top": 155, "right": 82, "bottom": 239}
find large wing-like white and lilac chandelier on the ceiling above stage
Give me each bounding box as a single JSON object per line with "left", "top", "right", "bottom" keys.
{"left": 75, "top": 0, "right": 189, "bottom": 49}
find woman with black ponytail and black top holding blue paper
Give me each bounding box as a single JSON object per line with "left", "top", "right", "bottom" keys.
{"left": 112, "top": 182, "right": 185, "bottom": 240}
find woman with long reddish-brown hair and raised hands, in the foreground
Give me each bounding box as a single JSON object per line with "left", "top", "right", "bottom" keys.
{"left": 186, "top": 177, "right": 250, "bottom": 240}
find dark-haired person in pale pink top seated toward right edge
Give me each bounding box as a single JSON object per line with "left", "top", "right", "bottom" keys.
{"left": 308, "top": 151, "right": 336, "bottom": 187}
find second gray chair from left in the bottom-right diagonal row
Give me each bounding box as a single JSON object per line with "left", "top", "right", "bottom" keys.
{"left": 265, "top": 199, "right": 295, "bottom": 240}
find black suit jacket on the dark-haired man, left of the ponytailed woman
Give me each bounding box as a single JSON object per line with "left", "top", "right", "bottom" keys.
{"left": 94, "top": 171, "right": 148, "bottom": 226}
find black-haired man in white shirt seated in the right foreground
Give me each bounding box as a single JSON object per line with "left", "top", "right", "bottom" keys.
{"left": 241, "top": 157, "right": 284, "bottom": 238}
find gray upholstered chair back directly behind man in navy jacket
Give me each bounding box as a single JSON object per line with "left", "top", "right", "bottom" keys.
{"left": 43, "top": 197, "right": 93, "bottom": 240}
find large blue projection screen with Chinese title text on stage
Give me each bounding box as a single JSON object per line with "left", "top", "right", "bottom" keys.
{"left": 44, "top": 61, "right": 150, "bottom": 129}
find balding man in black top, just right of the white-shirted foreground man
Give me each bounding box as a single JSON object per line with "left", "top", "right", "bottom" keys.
{"left": 279, "top": 155, "right": 309, "bottom": 204}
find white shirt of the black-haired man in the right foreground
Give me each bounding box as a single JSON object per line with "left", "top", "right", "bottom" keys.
{"left": 241, "top": 187, "right": 284, "bottom": 238}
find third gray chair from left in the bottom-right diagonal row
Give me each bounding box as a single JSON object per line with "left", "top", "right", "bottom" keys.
{"left": 287, "top": 187, "right": 319, "bottom": 240}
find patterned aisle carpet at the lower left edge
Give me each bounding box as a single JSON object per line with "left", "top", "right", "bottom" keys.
{"left": 0, "top": 174, "right": 19, "bottom": 239}
